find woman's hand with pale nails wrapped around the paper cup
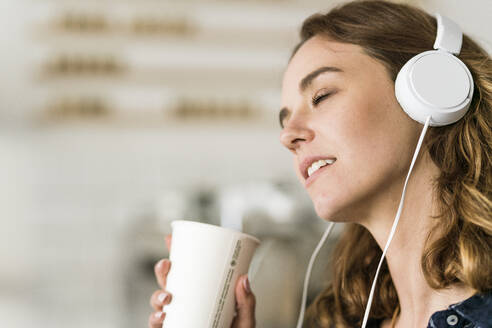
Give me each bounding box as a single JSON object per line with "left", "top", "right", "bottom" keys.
{"left": 149, "top": 235, "right": 256, "bottom": 328}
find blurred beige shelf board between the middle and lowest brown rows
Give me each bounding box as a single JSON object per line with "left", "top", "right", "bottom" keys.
{"left": 34, "top": 68, "right": 281, "bottom": 90}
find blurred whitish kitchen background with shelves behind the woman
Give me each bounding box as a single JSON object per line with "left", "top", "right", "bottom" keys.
{"left": 0, "top": 0, "right": 492, "bottom": 328}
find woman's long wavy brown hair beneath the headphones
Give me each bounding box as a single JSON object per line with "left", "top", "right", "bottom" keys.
{"left": 294, "top": 0, "right": 492, "bottom": 327}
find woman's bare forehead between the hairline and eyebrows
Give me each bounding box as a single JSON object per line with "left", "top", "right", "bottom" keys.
{"left": 282, "top": 36, "right": 368, "bottom": 89}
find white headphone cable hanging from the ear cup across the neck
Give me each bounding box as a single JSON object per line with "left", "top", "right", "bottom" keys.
{"left": 361, "top": 116, "right": 431, "bottom": 328}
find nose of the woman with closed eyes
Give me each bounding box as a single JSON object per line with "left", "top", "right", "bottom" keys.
{"left": 280, "top": 113, "right": 314, "bottom": 154}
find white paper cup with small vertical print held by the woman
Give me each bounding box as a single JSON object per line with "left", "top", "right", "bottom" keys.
{"left": 162, "top": 220, "right": 260, "bottom": 328}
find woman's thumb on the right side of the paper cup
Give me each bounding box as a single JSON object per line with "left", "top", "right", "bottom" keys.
{"left": 231, "top": 275, "right": 256, "bottom": 328}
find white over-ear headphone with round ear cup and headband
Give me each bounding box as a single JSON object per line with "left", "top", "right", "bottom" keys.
{"left": 395, "top": 14, "right": 473, "bottom": 126}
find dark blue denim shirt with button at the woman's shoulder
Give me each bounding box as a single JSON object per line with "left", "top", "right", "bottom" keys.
{"left": 427, "top": 291, "right": 492, "bottom": 328}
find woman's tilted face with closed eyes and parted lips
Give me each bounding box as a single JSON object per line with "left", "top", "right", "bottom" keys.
{"left": 280, "top": 36, "right": 421, "bottom": 221}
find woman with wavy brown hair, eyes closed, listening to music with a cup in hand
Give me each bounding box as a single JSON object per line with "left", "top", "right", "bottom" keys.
{"left": 149, "top": 1, "right": 492, "bottom": 328}
